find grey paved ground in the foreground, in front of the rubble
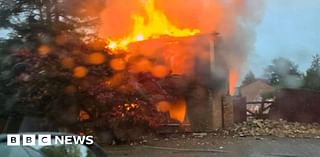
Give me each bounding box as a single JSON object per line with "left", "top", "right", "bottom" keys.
{"left": 105, "top": 137, "right": 320, "bottom": 157}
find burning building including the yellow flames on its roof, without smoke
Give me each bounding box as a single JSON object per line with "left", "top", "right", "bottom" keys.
{"left": 96, "top": 0, "right": 246, "bottom": 130}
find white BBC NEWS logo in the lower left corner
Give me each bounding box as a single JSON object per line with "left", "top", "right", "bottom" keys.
{"left": 7, "top": 134, "right": 94, "bottom": 146}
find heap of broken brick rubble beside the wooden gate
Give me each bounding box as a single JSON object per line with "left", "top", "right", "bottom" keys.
{"left": 222, "top": 119, "right": 320, "bottom": 138}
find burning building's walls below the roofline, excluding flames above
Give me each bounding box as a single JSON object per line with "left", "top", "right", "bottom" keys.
{"left": 128, "top": 33, "right": 234, "bottom": 130}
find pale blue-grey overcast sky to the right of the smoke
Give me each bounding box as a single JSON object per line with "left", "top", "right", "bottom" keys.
{"left": 0, "top": 0, "right": 320, "bottom": 76}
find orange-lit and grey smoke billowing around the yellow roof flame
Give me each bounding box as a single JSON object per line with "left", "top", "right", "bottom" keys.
{"left": 100, "top": 0, "right": 263, "bottom": 81}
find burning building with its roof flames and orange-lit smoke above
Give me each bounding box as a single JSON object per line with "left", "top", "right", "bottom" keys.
{"left": 96, "top": 0, "right": 264, "bottom": 130}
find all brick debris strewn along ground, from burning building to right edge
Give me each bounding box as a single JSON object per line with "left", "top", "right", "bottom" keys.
{"left": 106, "top": 119, "right": 320, "bottom": 145}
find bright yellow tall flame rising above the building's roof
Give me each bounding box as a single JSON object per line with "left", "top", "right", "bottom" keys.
{"left": 107, "top": 0, "right": 200, "bottom": 49}
